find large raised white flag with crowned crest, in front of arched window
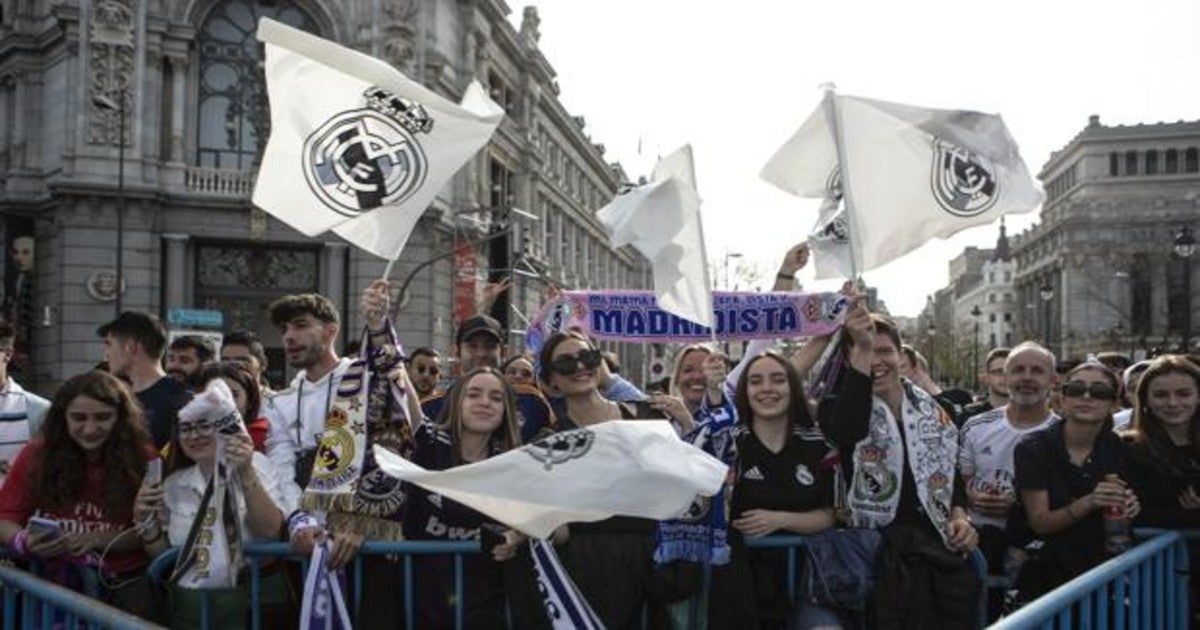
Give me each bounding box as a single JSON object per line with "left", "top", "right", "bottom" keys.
{"left": 253, "top": 18, "right": 504, "bottom": 259}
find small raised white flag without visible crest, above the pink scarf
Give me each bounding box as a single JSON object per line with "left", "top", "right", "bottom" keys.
{"left": 596, "top": 145, "right": 713, "bottom": 326}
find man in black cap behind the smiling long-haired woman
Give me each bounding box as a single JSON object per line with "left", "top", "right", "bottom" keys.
{"left": 414, "top": 314, "right": 554, "bottom": 442}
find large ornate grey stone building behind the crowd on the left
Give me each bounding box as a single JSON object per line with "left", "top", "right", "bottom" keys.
{"left": 0, "top": 0, "right": 649, "bottom": 390}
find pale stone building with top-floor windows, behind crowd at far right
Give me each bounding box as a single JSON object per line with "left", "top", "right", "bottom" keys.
{"left": 1013, "top": 115, "right": 1200, "bottom": 358}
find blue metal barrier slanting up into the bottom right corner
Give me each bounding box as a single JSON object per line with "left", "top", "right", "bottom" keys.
{"left": 991, "top": 532, "right": 1190, "bottom": 630}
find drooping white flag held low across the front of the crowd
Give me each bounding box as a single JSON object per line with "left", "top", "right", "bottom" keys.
{"left": 374, "top": 420, "right": 726, "bottom": 538}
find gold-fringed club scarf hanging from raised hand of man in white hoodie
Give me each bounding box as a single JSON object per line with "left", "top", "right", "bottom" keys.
{"left": 304, "top": 322, "right": 413, "bottom": 540}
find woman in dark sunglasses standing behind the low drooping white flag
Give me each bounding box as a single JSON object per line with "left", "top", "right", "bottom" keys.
{"left": 539, "top": 332, "right": 686, "bottom": 629}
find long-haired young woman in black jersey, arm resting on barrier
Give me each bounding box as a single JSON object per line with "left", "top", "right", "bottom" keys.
{"left": 709, "top": 345, "right": 871, "bottom": 629}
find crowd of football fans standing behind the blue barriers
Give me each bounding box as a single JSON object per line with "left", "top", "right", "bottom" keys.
{"left": 0, "top": 244, "right": 1200, "bottom": 629}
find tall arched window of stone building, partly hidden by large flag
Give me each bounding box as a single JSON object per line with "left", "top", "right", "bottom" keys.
{"left": 196, "top": 0, "right": 318, "bottom": 170}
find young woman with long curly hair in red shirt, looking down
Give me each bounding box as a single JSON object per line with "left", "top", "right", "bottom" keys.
{"left": 0, "top": 372, "right": 157, "bottom": 618}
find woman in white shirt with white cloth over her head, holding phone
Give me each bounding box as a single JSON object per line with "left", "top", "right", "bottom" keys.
{"left": 134, "top": 373, "right": 284, "bottom": 628}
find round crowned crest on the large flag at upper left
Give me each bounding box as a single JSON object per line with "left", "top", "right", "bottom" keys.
{"left": 301, "top": 86, "right": 433, "bottom": 217}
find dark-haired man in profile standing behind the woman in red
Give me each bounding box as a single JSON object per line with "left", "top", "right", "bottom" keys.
{"left": 96, "top": 311, "right": 192, "bottom": 449}
